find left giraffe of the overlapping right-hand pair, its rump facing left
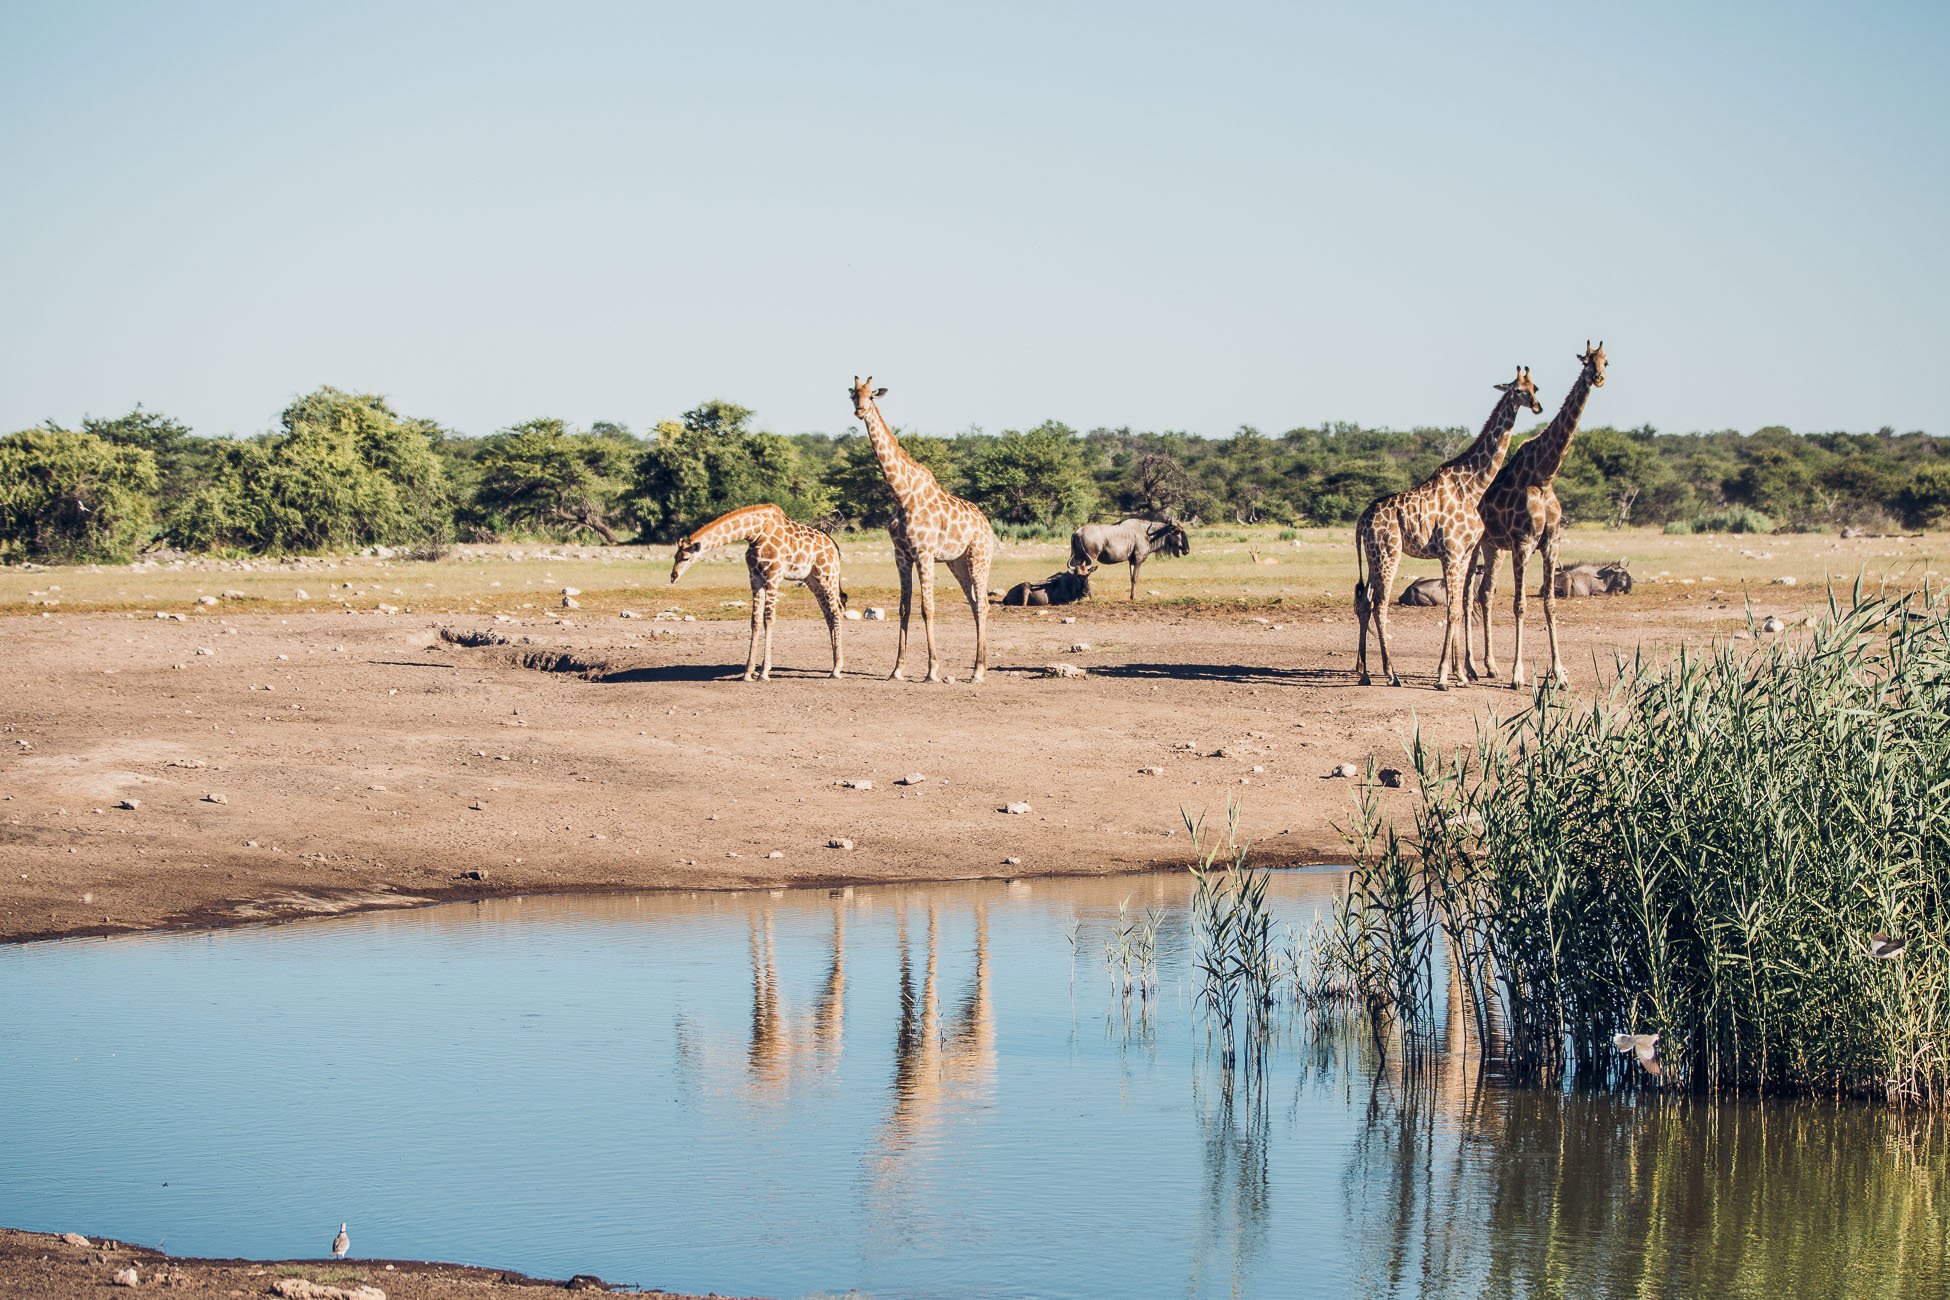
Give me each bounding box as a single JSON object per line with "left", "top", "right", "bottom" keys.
{"left": 1353, "top": 366, "right": 1544, "bottom": 690}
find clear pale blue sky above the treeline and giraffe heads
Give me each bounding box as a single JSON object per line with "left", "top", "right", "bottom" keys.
{"left": 0, "top": 0, "right": 1950, "bottom": 435}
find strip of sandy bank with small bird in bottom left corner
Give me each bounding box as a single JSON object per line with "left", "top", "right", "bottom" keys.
{"left": 0, "top": 1228, "right": 725, "bottom": 1300}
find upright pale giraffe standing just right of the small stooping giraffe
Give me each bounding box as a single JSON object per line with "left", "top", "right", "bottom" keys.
{"left": 848, "top": 374, "right": 996, "bottom": 682}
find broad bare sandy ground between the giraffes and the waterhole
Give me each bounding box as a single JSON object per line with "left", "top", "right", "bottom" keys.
{"left": 0, "top": 580, "right": 1770, "bottom": 939}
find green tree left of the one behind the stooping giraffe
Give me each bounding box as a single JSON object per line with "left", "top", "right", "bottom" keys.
{"left": 474, "top": 419, "right": 638, "bottom": 544}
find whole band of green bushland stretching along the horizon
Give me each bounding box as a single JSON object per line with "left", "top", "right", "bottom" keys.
{"left": 0, "top": 388, "right": 1950, "bottom": 559}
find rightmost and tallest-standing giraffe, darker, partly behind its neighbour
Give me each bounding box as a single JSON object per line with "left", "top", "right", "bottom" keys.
{"left": 1463, "top": 339, "right": 1605, "bottom": 690}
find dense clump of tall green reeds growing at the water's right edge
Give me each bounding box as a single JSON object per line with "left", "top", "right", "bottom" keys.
{"left": 1338, "top": 587, "right": 1950, "bottom": 1105}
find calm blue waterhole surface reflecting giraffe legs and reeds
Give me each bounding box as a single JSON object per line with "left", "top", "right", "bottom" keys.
{"left": 0, "top": 873, "right": 1950, "bottom": 1296}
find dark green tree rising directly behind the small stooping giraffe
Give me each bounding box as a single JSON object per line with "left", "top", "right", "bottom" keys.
{"left": 630, "top": 401, "right": 833, "bottom": 542}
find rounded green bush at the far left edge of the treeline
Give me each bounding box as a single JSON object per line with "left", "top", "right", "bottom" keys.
{"left": 0, "top": 429, "right": 156, "bottom": 561}
